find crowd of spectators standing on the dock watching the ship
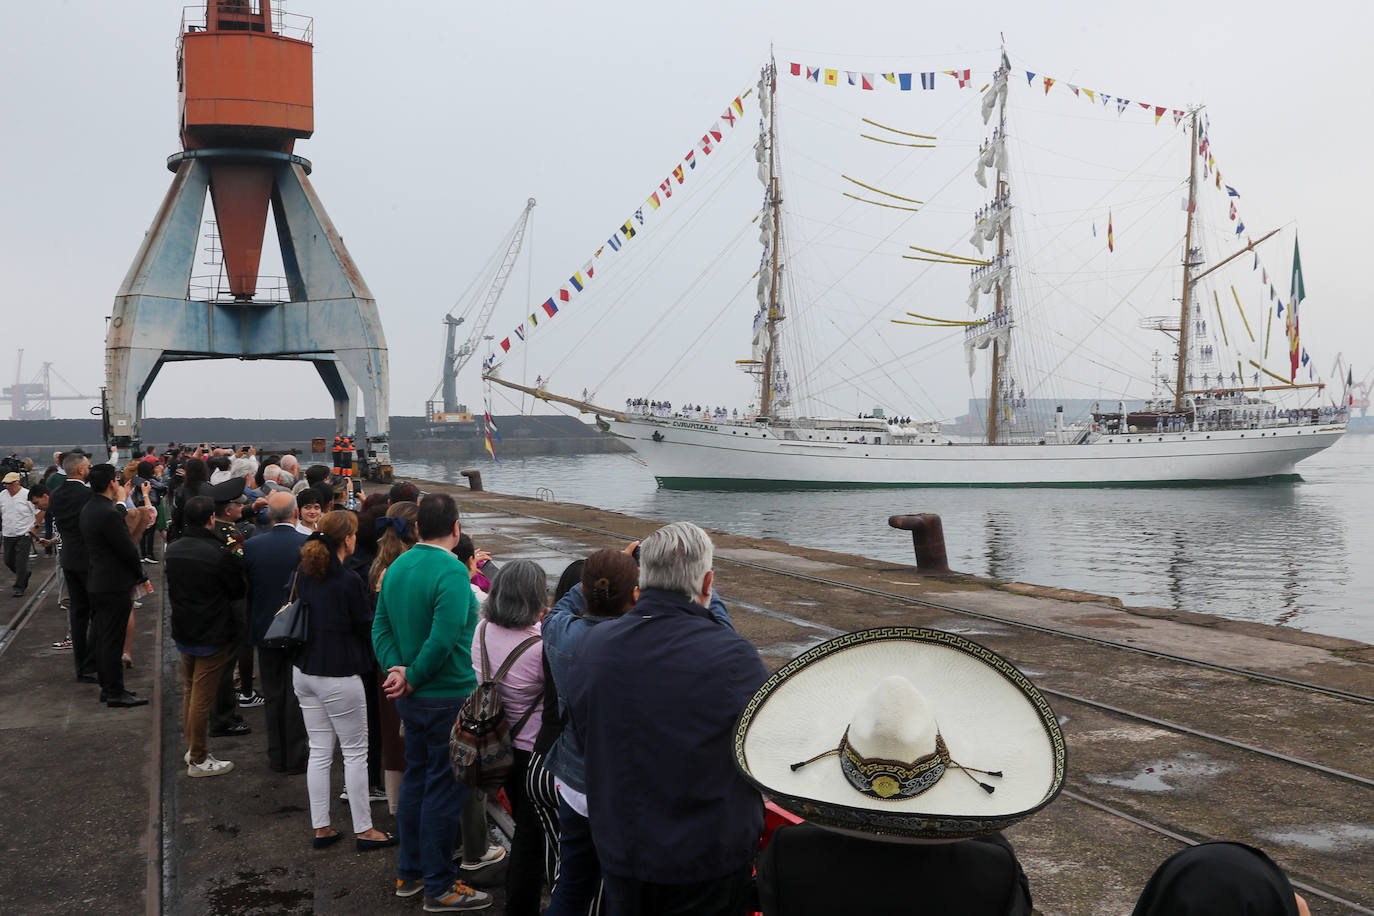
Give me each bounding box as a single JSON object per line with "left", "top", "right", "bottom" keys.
{"left": 8, "top": 446, "right": 1305, "bottom": 916}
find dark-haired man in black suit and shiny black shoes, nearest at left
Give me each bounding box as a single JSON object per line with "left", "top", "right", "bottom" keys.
{"left": 81, "top": 464, "right": 148, "bottom": 707}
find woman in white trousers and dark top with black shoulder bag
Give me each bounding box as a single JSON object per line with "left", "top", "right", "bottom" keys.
{"left": 291, "top": 509, "right": 396, "bottom": 851}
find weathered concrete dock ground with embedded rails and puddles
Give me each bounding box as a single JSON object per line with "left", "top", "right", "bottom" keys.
{"left": 0, "top": 482, "right": 1374, "bottom": 915}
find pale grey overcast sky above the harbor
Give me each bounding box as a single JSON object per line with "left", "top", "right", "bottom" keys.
{"left": 0, "top": 0, "right": 1374, "bottom": 417}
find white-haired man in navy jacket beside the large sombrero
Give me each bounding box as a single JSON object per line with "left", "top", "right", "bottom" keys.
{"left": 559, "top": 522, "right": 768, "bottom": 916}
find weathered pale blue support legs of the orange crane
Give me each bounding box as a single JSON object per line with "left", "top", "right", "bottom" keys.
{"left": 104, "top": 148, "right": 390, "bottom": 478}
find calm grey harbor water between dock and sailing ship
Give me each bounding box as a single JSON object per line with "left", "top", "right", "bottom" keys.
{"left": 396, "top": 435, "right": 1374, "bottom": 643}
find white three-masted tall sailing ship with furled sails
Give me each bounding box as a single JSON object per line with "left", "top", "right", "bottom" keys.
{"left": 484, "top": 52, "right": 1345, "bottom": 489}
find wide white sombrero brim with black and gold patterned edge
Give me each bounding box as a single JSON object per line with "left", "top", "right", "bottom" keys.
{"left": 734, "top": 626, "right": 1068, "bottom": 842}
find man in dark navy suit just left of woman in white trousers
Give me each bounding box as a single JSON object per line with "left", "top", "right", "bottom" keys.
{"left": 243, "top": 493, "right": 309, "bottom": 773}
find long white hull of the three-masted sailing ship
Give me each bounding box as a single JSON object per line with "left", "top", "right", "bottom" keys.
{"left": 607, "top": 416, "right": 1345, "bottom": 489}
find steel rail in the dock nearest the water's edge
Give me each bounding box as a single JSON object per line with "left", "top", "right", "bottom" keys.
{"left": 469, "top": 507, "right": 1374, "bottom": 706}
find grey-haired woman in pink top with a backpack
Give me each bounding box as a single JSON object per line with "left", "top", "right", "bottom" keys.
{"left": 473, "top": 560, "right": 548, "bottom": 916}
